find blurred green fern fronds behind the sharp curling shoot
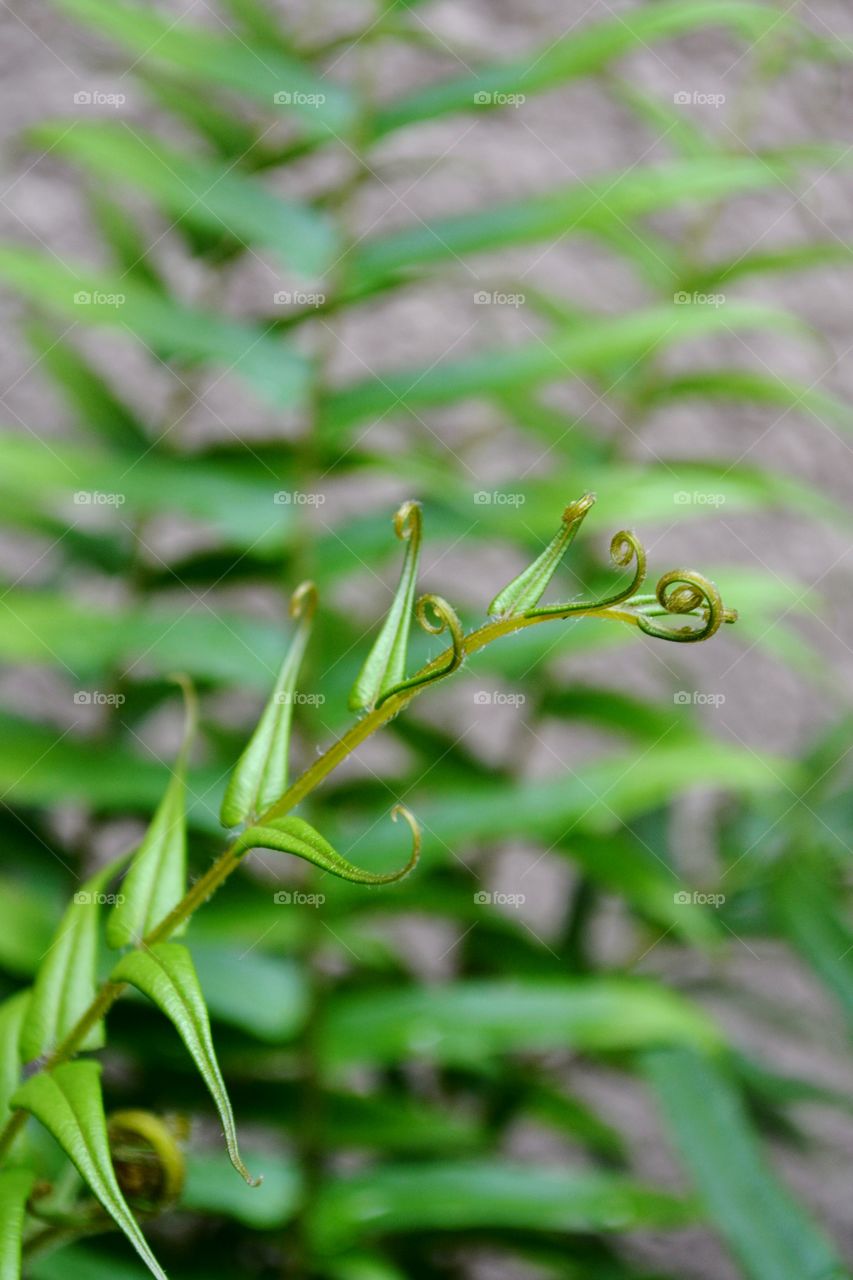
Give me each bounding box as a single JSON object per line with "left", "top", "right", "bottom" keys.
{"left": 0, "top": 0, "right": 853, "bottom": 1280}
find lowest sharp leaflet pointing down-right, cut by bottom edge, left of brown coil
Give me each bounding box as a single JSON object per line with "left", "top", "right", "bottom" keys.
{"left": 12, "top": 1061, "right": 168, "bottom": 1280}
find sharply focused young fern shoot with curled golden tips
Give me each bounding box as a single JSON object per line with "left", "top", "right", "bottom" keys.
{"left": 0, "top": 494, "right": 736, "bottom": 1280}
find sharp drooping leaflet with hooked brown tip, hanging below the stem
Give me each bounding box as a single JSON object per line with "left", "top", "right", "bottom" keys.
{"left": 110, "top": 942, "right": 257, "bottom": 1187}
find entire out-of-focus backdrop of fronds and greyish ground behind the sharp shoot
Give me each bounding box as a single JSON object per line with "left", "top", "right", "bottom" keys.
{"left": 0, "top": 0, "right": 853, "bottom": 1280}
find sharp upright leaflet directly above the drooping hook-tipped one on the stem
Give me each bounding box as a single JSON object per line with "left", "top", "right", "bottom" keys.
{"left": 106, "top": 680, "right": 196, "bottom": 947}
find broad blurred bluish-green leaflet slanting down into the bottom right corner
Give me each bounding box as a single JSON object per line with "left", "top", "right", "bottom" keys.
{"left": 646, "top": 1047, "right": 848, "bottom": 1280}
